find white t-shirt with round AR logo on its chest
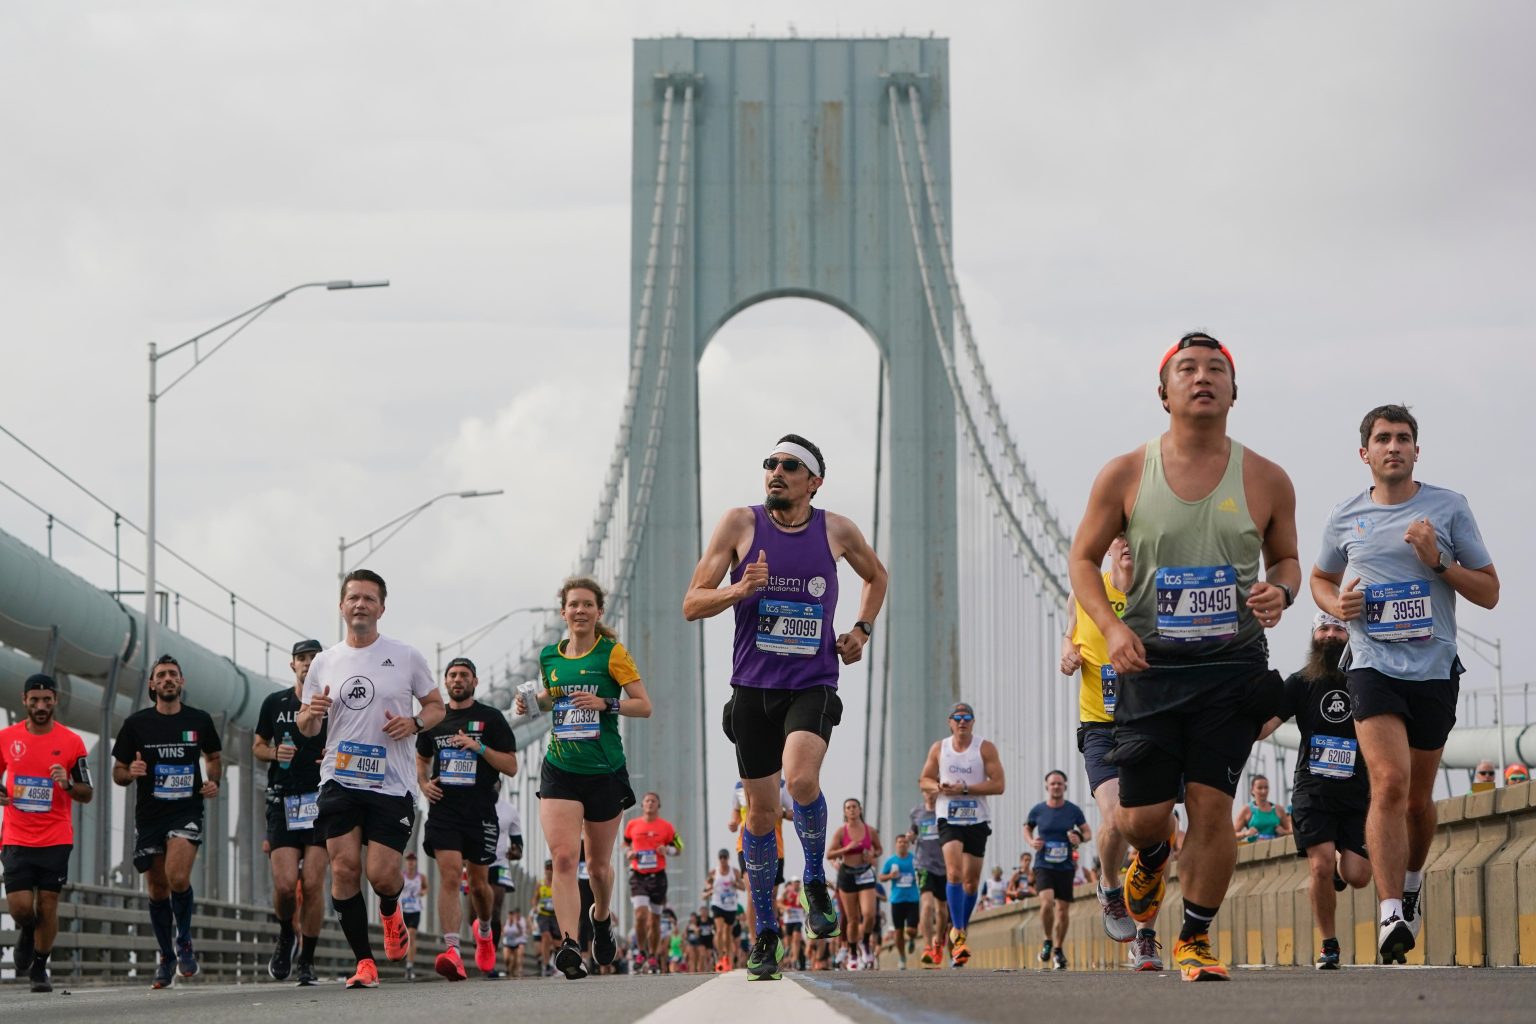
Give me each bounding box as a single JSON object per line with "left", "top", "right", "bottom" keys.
{"left": 303, "top": 636, "right": 438, "bottom": 797}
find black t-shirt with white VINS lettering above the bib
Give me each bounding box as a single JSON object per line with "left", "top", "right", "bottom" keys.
{"left": 112, "top": 705, "right": 224, "bottom": 823}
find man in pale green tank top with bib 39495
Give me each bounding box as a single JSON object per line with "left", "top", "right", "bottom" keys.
{"left": 1071, "top": 332, "right": 1301, "bottom": 981}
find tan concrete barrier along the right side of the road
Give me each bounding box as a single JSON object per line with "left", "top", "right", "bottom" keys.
{"left": 927, "top": 783, "right": 1536, "bottom": 970}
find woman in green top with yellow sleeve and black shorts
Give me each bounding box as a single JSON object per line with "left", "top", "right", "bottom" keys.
{"left": 513, "top": 577, "right": 651, "bottom": 979}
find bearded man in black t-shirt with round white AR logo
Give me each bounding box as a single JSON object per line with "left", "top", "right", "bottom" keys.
{"left": 1260, "top": 611, "right": 1370, "bottom": 970}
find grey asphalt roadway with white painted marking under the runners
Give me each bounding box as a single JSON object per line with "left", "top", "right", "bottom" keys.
{"left": 0, "top": 967, "right": 1536, "bottom": 1024}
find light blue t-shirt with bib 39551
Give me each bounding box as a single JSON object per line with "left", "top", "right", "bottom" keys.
{"left": 1318, "top": 484, "right": 1493, "bottom": 680}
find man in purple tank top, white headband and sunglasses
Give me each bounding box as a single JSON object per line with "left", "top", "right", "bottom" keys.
{"left": 682, "top": 434, "right": 888, "bottom": 981}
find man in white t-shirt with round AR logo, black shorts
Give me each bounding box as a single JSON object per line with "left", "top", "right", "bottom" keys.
{"left": 296, "top": 570, "right": 447, "bottom": 989}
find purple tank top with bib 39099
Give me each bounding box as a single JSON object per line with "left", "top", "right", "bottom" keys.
{"left": 731, "top": 505, "right": 837, "bottom": 689}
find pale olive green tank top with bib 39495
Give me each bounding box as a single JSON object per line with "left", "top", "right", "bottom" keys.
{"left": 1124, "top": 438, "right": 1264, "bottom": 665}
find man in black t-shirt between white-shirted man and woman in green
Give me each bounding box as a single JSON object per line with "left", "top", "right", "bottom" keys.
{"left": 416, "top": 657, "right": 518, "bottom": 981}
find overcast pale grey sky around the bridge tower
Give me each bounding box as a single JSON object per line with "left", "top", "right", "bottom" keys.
{"left": 0, "top": 0, "right": 1536, "bottom": 865}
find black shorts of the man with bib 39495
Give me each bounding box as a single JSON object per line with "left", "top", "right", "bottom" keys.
{"left": 1107, "top": 657, "right": 1284, "bottom": 808}
